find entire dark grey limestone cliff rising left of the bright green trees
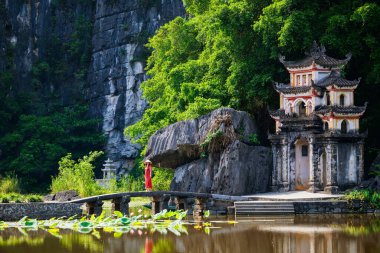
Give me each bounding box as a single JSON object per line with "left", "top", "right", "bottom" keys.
{"left": 0, "top": 0, "right": 184, "bottom": 172}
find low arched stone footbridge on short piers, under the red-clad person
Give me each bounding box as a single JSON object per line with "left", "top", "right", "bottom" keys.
{"left": 68, "top": 191, "right": 248, "bottom": 217}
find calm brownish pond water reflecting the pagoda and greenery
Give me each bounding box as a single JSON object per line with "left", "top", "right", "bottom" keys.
{"left": 0, "top": 215, "right": 380, "bottom": 253}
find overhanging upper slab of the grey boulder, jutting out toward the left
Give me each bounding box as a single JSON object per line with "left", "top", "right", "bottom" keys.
{"left": 146, "top": 108, "right": 257, "bottom": 168}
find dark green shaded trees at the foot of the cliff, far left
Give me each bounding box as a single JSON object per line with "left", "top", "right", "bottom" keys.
{"left": 0, "top": 106, "right": 104, "bottom": 192}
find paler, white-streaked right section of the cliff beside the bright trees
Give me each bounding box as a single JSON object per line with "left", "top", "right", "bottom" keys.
{"left": 85, "top": 0, "right": 185, "bottom": 173}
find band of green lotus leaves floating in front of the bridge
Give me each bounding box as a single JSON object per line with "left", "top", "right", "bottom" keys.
{"left": 0, "top": 209, "right": 223, "bottom": 239}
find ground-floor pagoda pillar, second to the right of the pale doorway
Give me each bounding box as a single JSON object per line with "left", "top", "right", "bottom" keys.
{"left": 324, "top": 141, "right": 339, "bottom": 193}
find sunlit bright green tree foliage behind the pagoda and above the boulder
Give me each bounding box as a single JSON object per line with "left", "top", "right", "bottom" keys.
{"left": 125, "top": 0, "right": 380, "bottom": 168}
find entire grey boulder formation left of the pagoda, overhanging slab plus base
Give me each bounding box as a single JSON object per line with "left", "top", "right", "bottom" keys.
{"left": 147, "top": 108, "right": 272, "bottom": 195}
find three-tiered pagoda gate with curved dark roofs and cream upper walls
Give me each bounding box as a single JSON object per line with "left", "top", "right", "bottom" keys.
{"left": 269, "top": 42, "right": 366, "bottom": 193}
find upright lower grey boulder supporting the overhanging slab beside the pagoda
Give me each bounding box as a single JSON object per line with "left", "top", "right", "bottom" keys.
{"left": 170, "top": 140, "right": 272, "bottom": 195}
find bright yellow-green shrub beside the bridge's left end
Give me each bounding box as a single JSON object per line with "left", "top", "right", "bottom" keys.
{"left": 51, "top": 151, "right": 103, "bottom": 197}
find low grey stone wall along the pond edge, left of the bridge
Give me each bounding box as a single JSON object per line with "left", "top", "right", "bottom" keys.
{"left": 0, "top": 203, "right": 83, "bottom": 221}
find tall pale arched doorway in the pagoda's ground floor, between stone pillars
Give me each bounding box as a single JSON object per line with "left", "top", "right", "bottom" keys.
{"left": 294, "top": 138, "right": 310, "bottom": 191}
